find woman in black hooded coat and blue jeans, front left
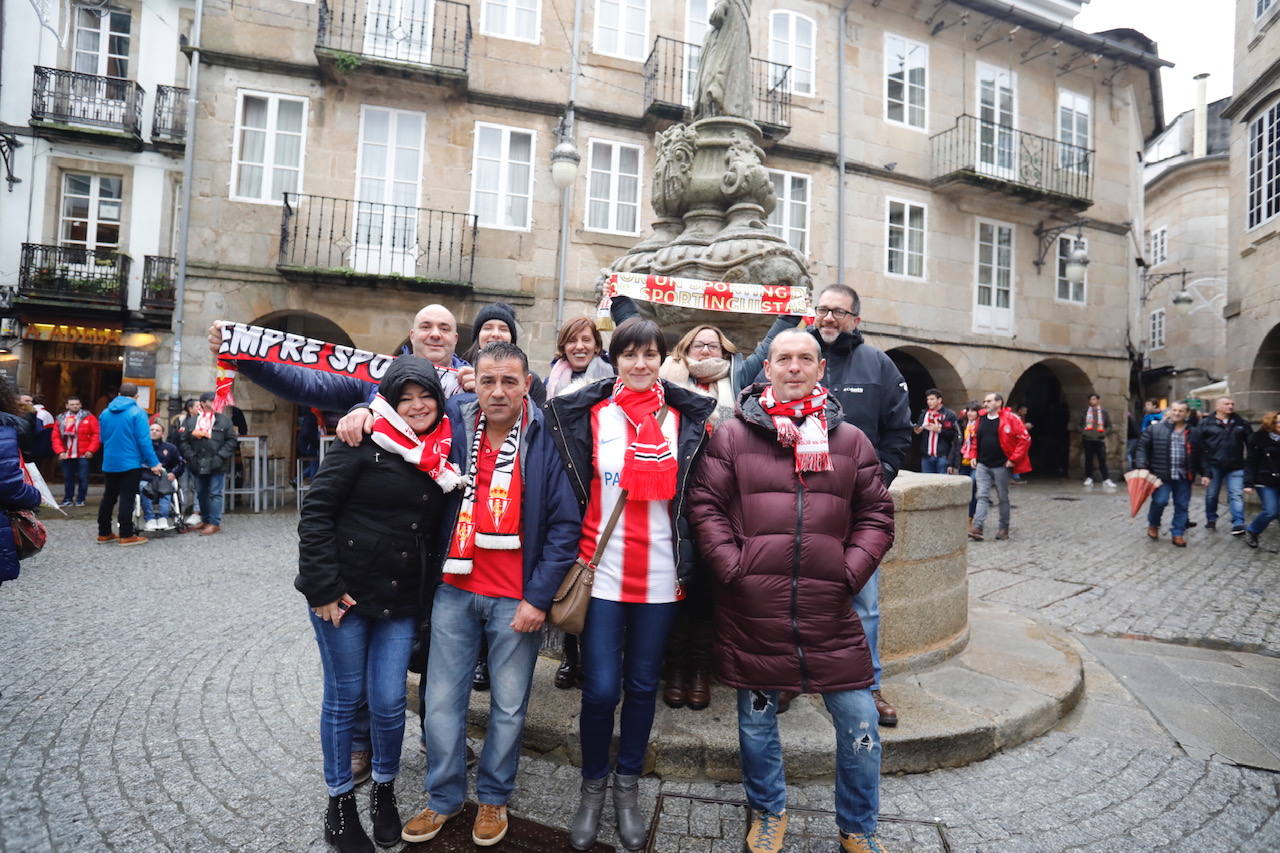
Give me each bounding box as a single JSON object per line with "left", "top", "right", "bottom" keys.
{"left": 293, "top": 356, "right": 461, "bottom": 852}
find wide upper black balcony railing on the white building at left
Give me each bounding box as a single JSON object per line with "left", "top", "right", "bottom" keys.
{"left": 31, "top": 65, "right": 143, "bottom": 136}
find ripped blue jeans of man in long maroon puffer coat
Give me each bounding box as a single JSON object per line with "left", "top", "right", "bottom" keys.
{"left": 737, "top": 689, "right": 881, "bottom": 833}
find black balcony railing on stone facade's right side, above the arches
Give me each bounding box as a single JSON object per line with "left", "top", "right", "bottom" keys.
{"left": 929, "top": 115, "right": 1093, "bottom": 209}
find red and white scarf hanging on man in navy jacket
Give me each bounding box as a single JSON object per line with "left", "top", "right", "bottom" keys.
{"left": 444, "top": 401, "right": 519, "bottom": 575}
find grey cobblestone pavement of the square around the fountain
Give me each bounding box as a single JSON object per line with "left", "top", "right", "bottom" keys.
{"left": 0, "top": 507, "right": 1280, "bottom": 853}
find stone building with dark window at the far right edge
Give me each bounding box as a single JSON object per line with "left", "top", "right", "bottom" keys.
{"left": 1224, "top": 0, "right": 1280, "bottom": 419}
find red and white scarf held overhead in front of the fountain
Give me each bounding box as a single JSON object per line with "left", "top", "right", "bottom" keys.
{"left": 605, "top": 273, "right": 813, "bottom": 316}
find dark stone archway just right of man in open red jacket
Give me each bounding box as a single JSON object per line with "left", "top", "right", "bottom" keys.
{"left": 1006, "top": 359, "right": 1093, "bottom": 476}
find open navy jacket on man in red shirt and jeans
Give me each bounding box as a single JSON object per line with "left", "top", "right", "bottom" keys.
{"left": 440, "top": 393, "right": 582, "bottom": 611}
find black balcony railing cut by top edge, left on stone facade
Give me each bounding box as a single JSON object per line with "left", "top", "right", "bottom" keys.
{"left": 316, "top": 0, "right": 471, "bottom": 74}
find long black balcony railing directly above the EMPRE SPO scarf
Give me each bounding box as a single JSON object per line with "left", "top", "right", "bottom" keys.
{"left": 279, "top": 192, "right": 476, "bottom": 286}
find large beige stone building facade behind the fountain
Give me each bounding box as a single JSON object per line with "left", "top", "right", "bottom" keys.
{"left": 7, "top": 0, "right": 1167, "bottom": 474}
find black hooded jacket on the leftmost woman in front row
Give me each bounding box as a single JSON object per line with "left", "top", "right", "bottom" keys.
{"left": 293, "top": 356, "right": 445, "bottom": 619}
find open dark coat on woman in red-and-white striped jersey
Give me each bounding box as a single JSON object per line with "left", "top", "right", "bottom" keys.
{"left": 544, "top": 379, "right": 716, "bottom": 584}
